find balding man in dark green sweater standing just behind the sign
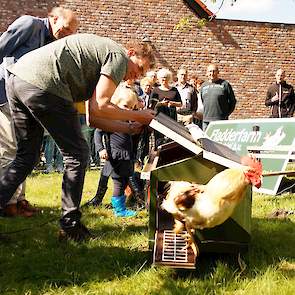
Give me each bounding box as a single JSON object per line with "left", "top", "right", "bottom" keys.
{"left": 200, "top": 64, "right": 236, "bottom": 131}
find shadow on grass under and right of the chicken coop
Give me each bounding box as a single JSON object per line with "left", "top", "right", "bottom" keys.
{"left": 165, "top": 218, "right": 295, "bottom": 280}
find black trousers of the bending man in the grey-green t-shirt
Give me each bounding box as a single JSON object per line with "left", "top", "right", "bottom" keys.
{"left": 0, "top": 75, "right": 89, "bottom": 228}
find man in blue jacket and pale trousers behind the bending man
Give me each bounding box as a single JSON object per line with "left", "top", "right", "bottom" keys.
{"left": 0, "top": 7, "right": 78, "bottom": 217}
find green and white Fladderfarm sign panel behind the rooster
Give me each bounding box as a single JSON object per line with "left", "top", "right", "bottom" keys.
{"left": 206, "top": 118, "right": 295, "bottom": 195}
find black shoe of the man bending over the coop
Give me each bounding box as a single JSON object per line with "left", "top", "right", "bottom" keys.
{"left": 58, "top": 222, "right": 94, "bottom": 242}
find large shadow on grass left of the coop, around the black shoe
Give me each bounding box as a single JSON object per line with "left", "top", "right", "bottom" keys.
{"left": 0, "top": 208, "right": 148, "bottom": 294}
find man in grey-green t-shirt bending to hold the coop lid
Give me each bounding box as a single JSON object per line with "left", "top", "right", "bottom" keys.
{"left": 0, "top": 34, "right": 154, "bottom": 241}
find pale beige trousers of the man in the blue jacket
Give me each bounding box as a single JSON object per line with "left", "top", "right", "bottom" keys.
{"left": 0, "top": 102, "right": 25, "bottom": 204}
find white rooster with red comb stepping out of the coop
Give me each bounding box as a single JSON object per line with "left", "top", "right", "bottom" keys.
{"left": 161, "top": 157, "right": 262, "bottom": 256}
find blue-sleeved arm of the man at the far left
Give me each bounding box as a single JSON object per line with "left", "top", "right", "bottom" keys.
{"left": 0, "top": 16, "right": 33, "bottom": 63}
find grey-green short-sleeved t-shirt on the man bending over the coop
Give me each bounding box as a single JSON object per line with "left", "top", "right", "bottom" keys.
{"left": 8, "top": 34, "right": 128, "bottom": 101}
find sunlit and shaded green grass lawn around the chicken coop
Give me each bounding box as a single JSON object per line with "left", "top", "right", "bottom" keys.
{"left": 0, "top": 171, "right": 295, "bottom": 295}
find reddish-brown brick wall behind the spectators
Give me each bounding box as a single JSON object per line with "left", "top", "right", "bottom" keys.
{"left": 0, "top": 0, "right": 295, "bottom": 118}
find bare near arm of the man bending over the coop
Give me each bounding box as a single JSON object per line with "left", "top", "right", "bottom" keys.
{"left": 87, "top": 75, "right": 154, "bottom": 129}
